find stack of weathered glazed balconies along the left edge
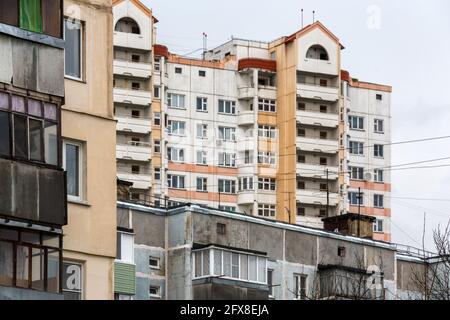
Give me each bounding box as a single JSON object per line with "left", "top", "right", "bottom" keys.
{"left": 0, "top": 0, "right": 67, "bottom": 300}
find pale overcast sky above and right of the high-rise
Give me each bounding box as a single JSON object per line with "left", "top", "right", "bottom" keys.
{"left": 143, "top": 0, "right": 450, "bottom": 249}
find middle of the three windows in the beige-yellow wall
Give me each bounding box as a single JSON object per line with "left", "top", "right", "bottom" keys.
{"left": 63, "top": 142, "right": 83, "bottom": 200}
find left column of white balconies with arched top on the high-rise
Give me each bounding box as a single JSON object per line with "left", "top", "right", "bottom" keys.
{"left": 113, "top": 0, "right": 156, "bottom": 200}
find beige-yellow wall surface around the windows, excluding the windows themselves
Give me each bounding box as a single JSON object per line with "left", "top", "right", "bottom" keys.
{"left": 62, "top": 0, "right": 116, "bottom": 299}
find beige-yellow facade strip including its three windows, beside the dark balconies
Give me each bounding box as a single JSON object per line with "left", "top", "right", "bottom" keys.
{"left": 61, "top": 0, "right": 117, "bottom": 300}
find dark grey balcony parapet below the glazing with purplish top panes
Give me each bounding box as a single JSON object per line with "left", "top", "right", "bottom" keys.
{"left": 0, "top": 159, "right": 67, "bottom": 227}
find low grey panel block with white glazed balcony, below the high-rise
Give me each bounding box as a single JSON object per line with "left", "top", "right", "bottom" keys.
{"left": 115, "top": 202, "right": 432, "bottom": 300}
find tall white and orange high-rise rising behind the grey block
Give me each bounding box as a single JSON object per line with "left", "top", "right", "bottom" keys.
{"left": 115, "top": 1, "right": 392, "bottom": 241}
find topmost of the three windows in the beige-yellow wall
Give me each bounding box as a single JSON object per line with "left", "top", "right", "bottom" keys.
{"left": 64, "top": 19, "right": 83, "bottom": 80}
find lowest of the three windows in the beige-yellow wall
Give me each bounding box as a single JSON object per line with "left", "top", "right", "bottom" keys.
{"left": 62, "top": 261, "right": 83, "bottom": 300}
